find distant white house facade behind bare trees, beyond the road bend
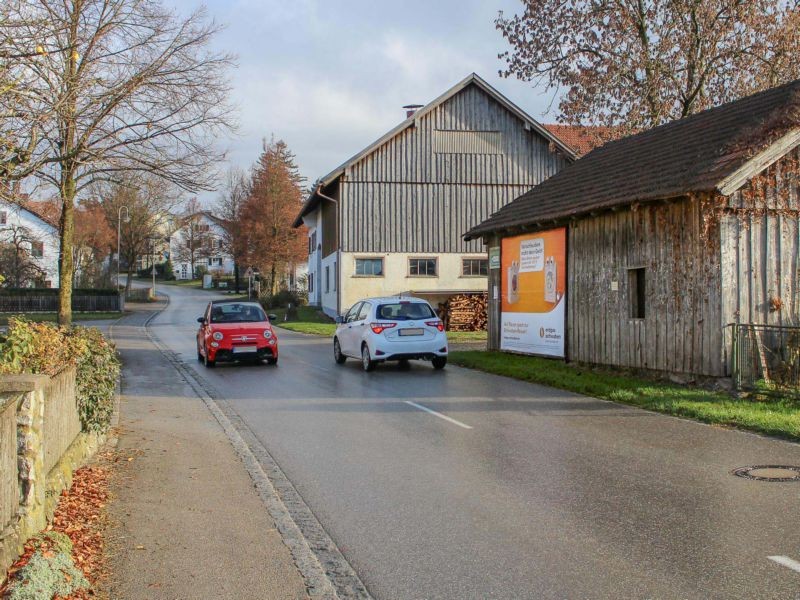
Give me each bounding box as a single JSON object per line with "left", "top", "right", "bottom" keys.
{"left": 169, "top": 212, "right": 234, "bottom": 279}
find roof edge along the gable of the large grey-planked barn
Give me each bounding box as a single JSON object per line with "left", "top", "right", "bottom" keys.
{"left": 292, "top": 73, "right": 577, "bottom": 227}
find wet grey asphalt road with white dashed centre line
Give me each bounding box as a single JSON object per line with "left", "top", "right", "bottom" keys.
{"left": 151, "top": 287, "right": 800, "bottom": 600}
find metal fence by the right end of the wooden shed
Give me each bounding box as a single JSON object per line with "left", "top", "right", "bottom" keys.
{"left": 731, "top": 324, "right": 800, "bottom": 393}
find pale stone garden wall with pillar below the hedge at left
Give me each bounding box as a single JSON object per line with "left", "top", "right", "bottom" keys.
{"left": 0, "top": 369, "right": 104, "bottom": 582}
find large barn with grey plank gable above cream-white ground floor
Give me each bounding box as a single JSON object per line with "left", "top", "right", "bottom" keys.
{"left": 294, "top": 73, "right": 576, "bottom": 315}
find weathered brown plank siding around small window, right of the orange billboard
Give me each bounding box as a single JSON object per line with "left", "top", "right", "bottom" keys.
{"left": 567, "top": 199, "right": 724, "bottom": 376}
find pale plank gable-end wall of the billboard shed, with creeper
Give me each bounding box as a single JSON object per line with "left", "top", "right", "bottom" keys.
{"left": 721, "top": 148, "right": 800, "bottom": 370}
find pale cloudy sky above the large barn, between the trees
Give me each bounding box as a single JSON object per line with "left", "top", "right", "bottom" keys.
{"left": 176, "top": 0, "right": 555, "bottom": 204}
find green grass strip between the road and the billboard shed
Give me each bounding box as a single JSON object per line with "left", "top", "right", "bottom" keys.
{"left": 449, "top": 351, "right": 800, "bottom": 441}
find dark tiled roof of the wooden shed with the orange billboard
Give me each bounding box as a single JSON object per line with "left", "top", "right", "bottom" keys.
{"left": 464, "top": 80, "right": 800, "bottom": 240}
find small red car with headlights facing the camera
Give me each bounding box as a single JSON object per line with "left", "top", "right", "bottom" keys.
{"left": 197, "top": 300, "right": 278, "bottom": 368}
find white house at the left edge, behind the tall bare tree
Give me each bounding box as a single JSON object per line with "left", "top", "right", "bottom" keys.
{"left": 0, "top": 200, "right": 60, "bottom": 287}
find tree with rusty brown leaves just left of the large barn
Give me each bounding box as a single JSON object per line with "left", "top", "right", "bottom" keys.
{"left": 237, "top": 140, "right": 306, "bottom": 294}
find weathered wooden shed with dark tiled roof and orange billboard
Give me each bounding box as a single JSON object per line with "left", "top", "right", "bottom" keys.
{"left": 465, "top": 81, "right": 800, "bottom": 378}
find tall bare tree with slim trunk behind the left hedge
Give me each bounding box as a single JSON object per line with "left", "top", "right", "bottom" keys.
{"left": 2, "top": 0, "right": 232, "bottom": 323}
